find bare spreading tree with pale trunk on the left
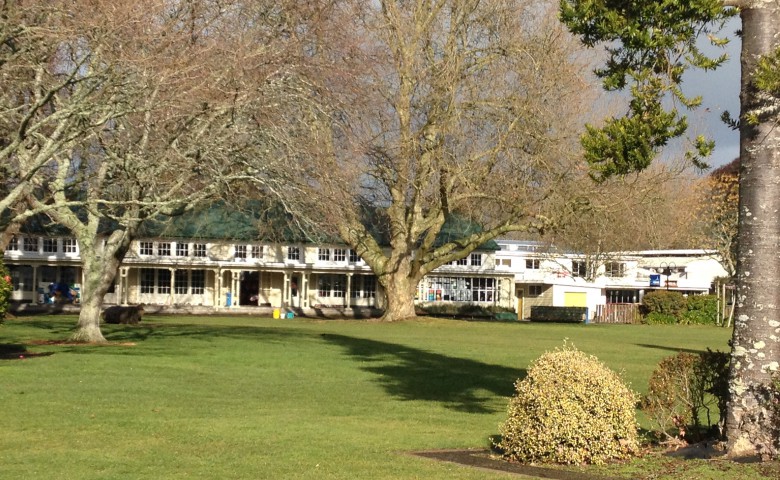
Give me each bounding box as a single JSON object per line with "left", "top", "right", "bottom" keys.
{"left": 8, "top": 0, "right": 324, "bottom": 342}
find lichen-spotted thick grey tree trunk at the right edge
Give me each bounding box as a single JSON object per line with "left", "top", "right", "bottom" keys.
{"left": 726, "top": 1, "right": 780, "bottom": 458}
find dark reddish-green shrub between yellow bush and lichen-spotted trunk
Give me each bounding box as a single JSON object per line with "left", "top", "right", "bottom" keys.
{"left": 641, "top": 350, "right": 729, "bottom": 440}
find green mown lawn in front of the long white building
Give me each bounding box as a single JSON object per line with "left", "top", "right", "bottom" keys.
{"left": 0, "top": 316, "right": 772, "bottom": 479}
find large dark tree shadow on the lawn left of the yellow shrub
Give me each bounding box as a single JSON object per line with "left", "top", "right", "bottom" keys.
{"left": 322, "top": 334, "right": 526, "bottom": 413}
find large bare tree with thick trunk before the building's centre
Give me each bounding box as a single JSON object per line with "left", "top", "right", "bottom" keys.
{"left": 268, "top": 0, "right": 589, "bottom": 321}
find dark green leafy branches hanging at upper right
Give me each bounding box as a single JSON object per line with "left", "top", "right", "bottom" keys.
{"left": 560, "top": 0, "right": 737, "bottom": 181}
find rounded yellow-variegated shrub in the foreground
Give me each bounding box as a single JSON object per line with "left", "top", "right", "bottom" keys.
{"left": 496, "top": 346, "right": 638, "bottom": 464}
